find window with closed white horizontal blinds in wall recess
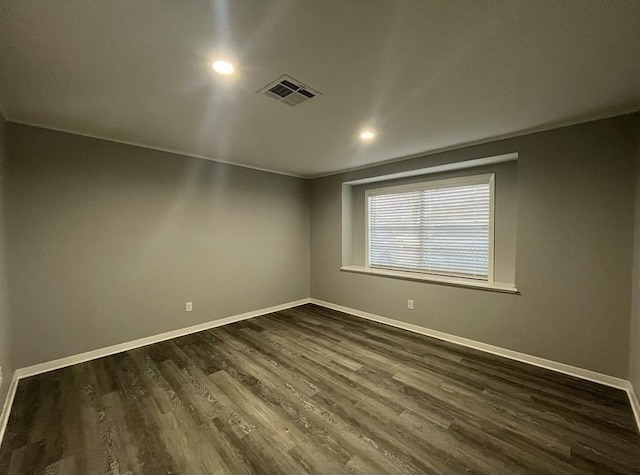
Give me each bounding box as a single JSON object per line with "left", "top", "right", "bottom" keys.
{"left": 366, "top": 174, "right": 494, "bottom": 283}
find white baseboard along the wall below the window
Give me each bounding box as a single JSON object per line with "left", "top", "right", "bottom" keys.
{"left": 311, "top": 298, "right": 629, "bottom": 391}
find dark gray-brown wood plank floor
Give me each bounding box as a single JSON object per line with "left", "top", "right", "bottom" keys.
{"left": 0, "top": 305, "right": 640, "bottom": 474}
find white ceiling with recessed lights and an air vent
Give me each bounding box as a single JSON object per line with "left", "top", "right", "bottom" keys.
{"left": 0, "top": 0, "right": 640, "bottom": 176}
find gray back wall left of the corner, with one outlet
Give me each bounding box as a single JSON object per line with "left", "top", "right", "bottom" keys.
{"left": 6, "top": 123, "right": 309, "bottom": 367}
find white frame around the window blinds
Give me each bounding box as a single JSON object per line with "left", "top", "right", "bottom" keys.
{"left": 364, "top": 173, "right": 495, "bottom": 286}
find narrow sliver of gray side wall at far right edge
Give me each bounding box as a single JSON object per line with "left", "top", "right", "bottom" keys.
{"left": 629, "top": 136, "right": 640, "bottom": 396}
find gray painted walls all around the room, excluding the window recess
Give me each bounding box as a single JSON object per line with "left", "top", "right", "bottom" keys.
{"left": 0, "top": 115, "right": 640, "bottom": 384}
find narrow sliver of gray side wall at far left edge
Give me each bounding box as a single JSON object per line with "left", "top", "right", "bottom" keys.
{"left": 0, "top": 112, "right": 13, "bottom": 411}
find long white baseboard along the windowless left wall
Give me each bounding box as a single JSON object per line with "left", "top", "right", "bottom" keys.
{"left": 16, "top": 299, "right": 310, "bottom": 379}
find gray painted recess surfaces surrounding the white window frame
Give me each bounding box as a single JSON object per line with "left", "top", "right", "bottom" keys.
{"left": 342, "top": 161, "right": 518, "bottom": 284}
